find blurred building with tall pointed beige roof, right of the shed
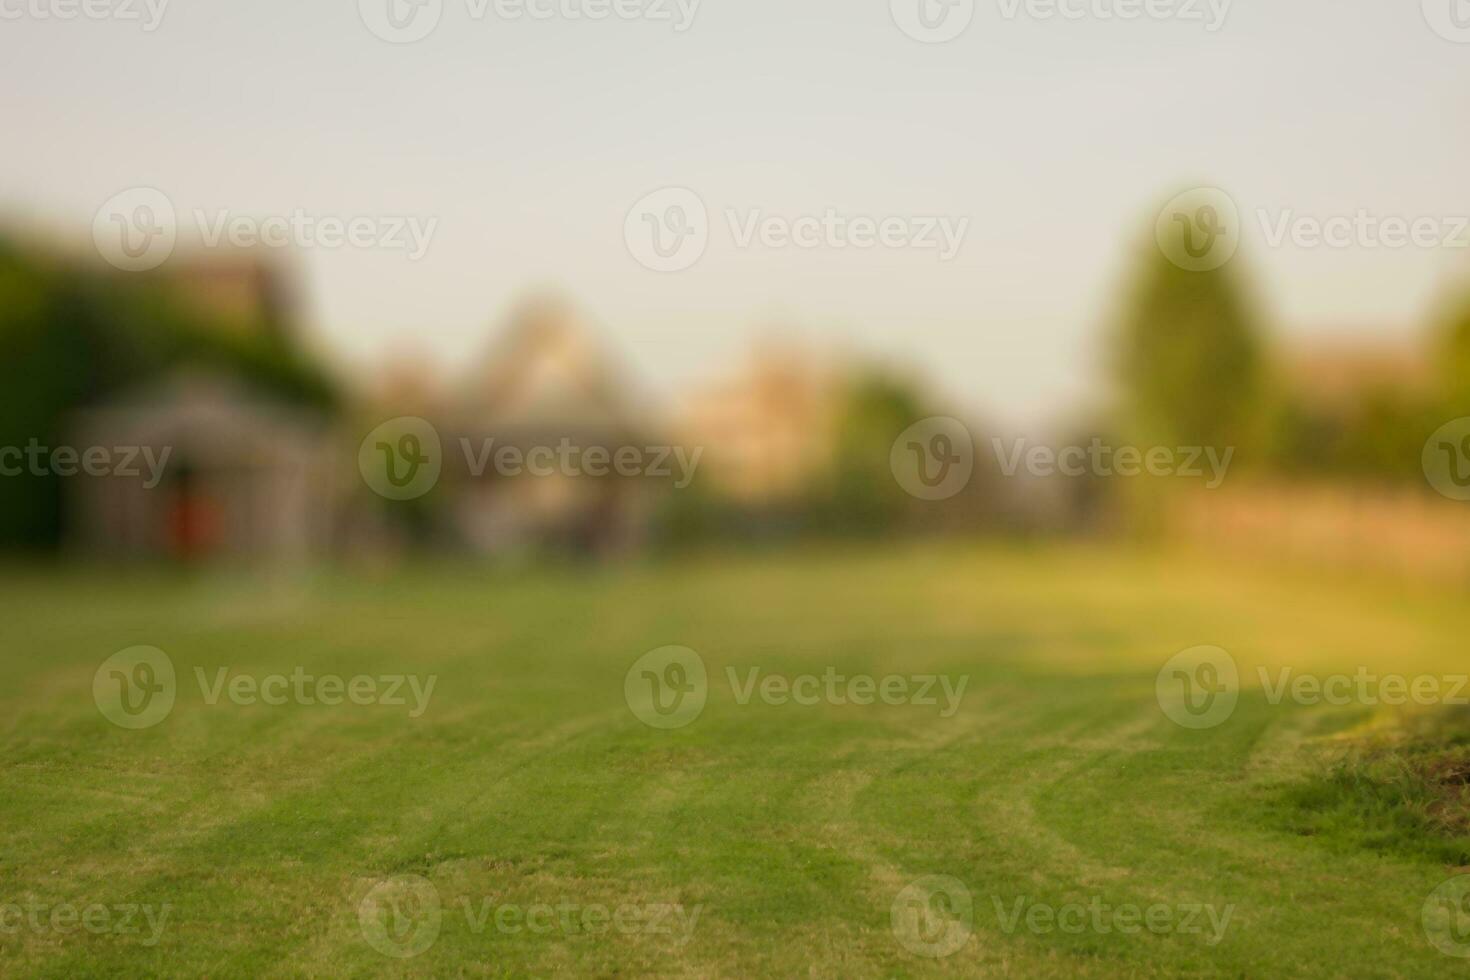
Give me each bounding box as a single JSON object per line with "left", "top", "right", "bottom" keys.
{"left": 441, "top": 300, "right": 663, "bottom": 555}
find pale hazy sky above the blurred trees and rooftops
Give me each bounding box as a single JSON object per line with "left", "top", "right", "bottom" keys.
{"left": 0, "top": 0, "right": 1470, "bottom": 423}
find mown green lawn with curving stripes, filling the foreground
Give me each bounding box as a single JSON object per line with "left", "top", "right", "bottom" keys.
{"left": 0, "top": 548, "right": 1470, "bottom": 977}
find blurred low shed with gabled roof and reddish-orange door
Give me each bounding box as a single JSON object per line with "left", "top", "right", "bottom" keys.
{"left": 66, "top": 373, "right": 338, "bottom": 561}
